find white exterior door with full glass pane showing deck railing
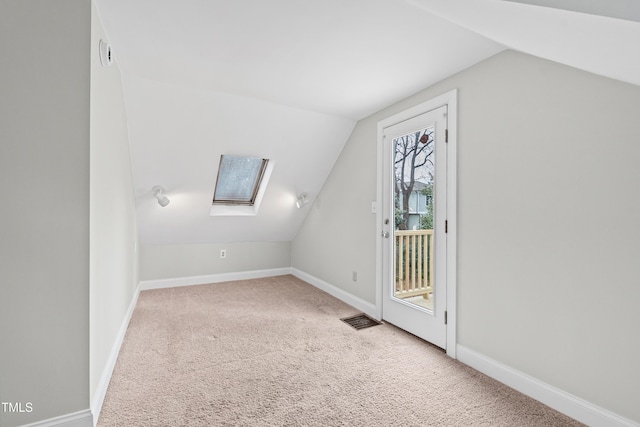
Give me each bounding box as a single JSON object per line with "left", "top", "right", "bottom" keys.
{"left": 381, "top": 106, "right": 448, "bottom": 349}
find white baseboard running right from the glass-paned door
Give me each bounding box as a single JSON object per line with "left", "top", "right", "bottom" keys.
{"left": 457, "top": 345, "right": 640, "bottom": 427}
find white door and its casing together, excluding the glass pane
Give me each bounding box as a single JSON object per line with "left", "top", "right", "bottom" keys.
{"left": 376, "top": 90, "right": 457, "bottom": 358}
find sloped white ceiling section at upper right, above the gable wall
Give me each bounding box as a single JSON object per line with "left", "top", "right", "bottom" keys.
{"left": 406, "top": 0, "right": 640, "bottom": 85}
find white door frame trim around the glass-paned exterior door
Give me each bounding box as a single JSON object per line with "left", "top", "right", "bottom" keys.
{"left": 376, "top": 89, "right": 458, "bottom": 359}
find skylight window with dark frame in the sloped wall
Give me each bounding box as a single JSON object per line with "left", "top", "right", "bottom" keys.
{"left": 213, "top": 155, "right": 268, "bottom": 206}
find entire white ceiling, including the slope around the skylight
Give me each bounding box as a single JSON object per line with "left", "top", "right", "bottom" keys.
{"left": 97, "top": 0, "right": 640, "bottom": 244}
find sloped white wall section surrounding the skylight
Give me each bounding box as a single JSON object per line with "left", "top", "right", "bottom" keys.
{"left": 122, "top": 74, "right": 355, "bottom": 245}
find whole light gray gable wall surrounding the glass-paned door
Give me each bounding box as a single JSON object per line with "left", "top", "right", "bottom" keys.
{"left": 292, "top": 51, "right": 640, "bottom": 422}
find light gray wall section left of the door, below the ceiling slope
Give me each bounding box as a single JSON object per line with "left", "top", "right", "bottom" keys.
{"left": 291, "top": 119, "right": 377, "bottom": 303}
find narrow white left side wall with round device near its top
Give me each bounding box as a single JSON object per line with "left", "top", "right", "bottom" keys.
{"left": 90, "top": 1, "right": 138, "bottom": 415}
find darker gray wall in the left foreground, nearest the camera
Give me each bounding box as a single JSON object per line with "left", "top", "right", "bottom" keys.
{"left": 0, "top": 0, "right": 91, "bottom": 427}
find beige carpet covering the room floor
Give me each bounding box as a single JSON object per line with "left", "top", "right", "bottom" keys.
{"left": 98, "top": 276, "right": 581, "bottom": 427}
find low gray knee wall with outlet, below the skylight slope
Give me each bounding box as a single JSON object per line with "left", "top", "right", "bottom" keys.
{"left": 140, "top": 242, "right": 291, "bottom": 280}
